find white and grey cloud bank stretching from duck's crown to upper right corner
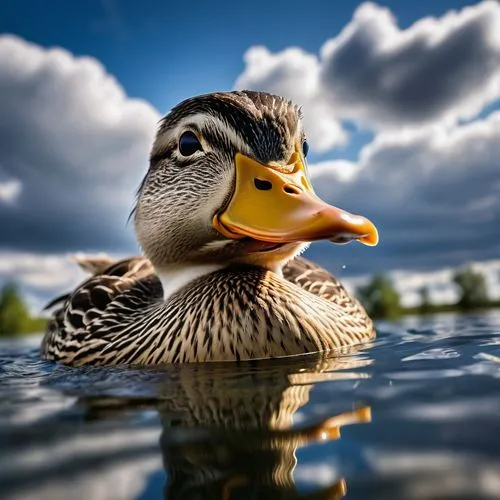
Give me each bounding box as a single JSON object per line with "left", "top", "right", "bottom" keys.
{"left": 236, "top": 1, "right": 500, "bottom": 151}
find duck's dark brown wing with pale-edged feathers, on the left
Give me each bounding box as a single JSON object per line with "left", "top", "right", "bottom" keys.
{"left": 41, "top": 257, "right": 162, "bottom": 364}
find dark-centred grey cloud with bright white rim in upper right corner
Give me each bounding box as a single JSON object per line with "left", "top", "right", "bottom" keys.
{"left": 321, "top": 2, "right": 500, "bottom": 126}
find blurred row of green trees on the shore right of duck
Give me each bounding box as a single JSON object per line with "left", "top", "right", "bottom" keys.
{"left": 356, "top": 267, "right": 500, "bottom": 319}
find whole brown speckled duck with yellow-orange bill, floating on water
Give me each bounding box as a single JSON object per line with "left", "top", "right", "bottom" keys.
{"left": 41, "top": 90, "right": 378, "bottom": 366}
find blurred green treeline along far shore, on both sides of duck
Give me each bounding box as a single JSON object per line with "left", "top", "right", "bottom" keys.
{"left": 0, "top": 267, "right": 500, "bottom": 336}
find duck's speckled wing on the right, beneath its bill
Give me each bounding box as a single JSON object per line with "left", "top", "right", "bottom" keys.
{"left": 283, "top": 257, "right": 360, "bottom": 309}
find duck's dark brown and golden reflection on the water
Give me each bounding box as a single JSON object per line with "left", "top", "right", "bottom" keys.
{"left": 79, "top": 356, "right": 371, "bottom": 500}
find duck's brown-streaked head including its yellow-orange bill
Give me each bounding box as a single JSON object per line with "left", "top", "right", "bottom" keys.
{"left": 135, "top": 91, "right": 377, "bottom": 276}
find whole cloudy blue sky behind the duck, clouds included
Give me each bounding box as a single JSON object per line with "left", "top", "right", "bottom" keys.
{"left": 0, "top": 0, "right": 500, "bottom": 306}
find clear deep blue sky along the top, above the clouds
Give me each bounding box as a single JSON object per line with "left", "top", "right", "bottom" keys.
{"left": 0, "top": 0, "right": 475, "bottom": 135}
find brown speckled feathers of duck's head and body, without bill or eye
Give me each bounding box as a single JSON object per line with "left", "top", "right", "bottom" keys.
{"left": 42, "top": 92, "right": 374, "bottom": 365}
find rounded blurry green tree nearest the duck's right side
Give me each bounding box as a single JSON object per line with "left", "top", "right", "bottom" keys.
{"left": 357, "top": 275, "right": 401, "bottom": 318}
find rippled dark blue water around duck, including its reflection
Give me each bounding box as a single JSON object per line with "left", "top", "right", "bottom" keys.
{"left": 0, "top": 311, "right": 500, "bottom": 500}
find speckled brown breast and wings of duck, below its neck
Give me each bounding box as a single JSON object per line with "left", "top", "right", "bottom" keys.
{"left": 43, "top": 257, "right": 374, "bottom": 365}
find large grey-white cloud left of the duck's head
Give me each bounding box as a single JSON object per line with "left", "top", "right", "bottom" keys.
{"left": 0, "top": 36, "right": 159, "bottom": 251}
